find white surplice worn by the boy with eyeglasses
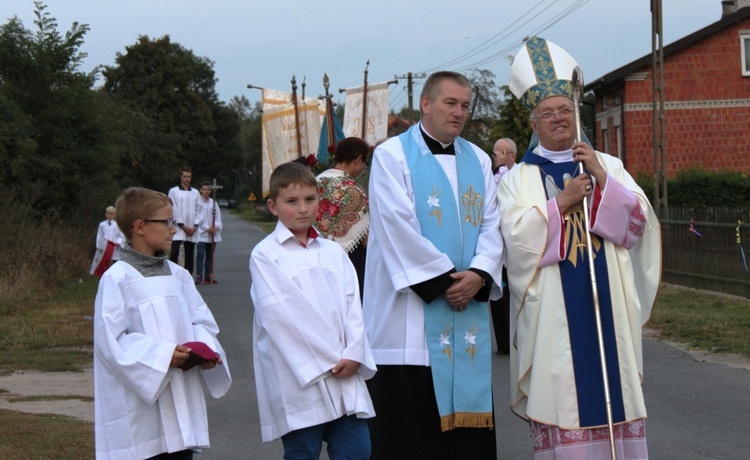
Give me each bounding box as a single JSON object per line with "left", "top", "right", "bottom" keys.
{"left": 94, "top": 262, "right": 232, "bottom": 460}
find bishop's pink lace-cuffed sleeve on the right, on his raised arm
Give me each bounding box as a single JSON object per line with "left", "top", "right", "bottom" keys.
{"left": 590, "top": 175, "right": 646, "bottom": 249}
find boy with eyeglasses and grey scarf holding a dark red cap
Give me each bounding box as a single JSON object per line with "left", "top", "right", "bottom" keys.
{"left": 94, "top": 187, "right": 232, "bottom": 459}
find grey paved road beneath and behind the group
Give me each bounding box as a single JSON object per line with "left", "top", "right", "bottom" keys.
{"left": 196, "top": 212, "right": 750, "bottom": 460}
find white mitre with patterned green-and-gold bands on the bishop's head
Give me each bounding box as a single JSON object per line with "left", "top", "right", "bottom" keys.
{"left": 508, "top": 37, "right": 578, "bottom": 111}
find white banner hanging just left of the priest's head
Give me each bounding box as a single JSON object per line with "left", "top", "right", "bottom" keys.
{"left": 342, "top": 83, "right": 388, "bottom": 145}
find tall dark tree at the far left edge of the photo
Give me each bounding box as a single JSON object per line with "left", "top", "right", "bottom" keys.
{"left": 0, "top": 2, "right": 120, "bottom": 215}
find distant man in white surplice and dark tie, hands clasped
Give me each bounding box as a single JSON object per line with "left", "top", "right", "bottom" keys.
{"left": 169, "top": 166, "right": 203, "bottom": 275}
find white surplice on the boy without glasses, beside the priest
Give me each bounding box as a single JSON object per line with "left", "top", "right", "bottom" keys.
{"left": 250, "top": 222, "right": 376, "bottom": 441}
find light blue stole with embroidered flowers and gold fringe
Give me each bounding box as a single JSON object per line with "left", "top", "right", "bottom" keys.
{"left": 402, "top": 125, "right": 493, "bottom": 431}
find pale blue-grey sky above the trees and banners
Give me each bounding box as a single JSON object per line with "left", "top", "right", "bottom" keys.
{"left": 0, "top": 0, "right": 722, "bottom": 110}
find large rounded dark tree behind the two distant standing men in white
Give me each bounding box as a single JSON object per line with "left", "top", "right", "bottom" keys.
{"left": 103, "top": 35, "right": 240, "bottom": 190}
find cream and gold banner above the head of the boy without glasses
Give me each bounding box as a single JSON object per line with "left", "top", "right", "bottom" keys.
{"left": 262, "top": 96, "right": 320, "bottom": 198}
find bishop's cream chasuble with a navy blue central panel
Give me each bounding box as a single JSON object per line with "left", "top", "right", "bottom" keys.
{"left": 498, "top": 147, "right": 661, "bottom": 429}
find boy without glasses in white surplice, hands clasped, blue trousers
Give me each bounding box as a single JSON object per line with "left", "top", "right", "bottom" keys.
{"left": 250, "top": 163, "right": 375, "bottom": 460}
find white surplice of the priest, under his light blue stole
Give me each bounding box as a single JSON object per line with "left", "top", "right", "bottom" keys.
{"left": 363, "top": 130, "right": 504, "bottom": 366}
